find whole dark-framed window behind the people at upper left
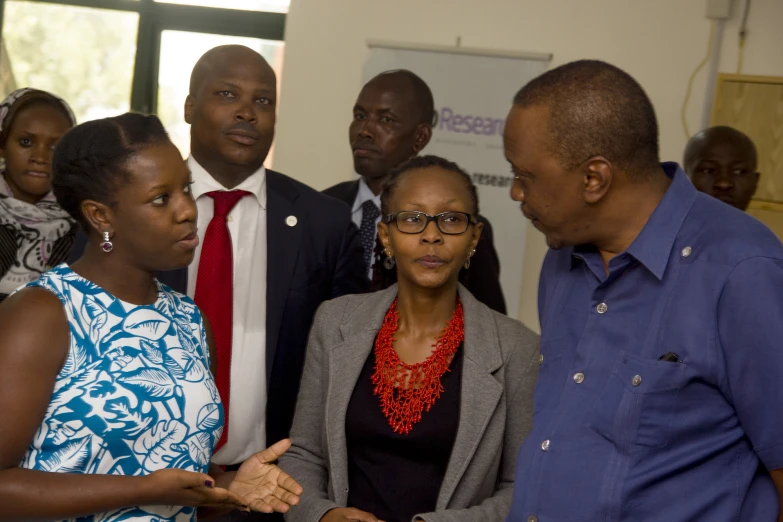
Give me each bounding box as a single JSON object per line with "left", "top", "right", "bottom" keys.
{"left": 0, "top": 0, "right": 290, "bottom": 164}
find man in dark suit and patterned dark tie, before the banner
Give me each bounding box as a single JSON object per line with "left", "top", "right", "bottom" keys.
{"left": 324, "top": 70, "right": 506, "bottom": 313}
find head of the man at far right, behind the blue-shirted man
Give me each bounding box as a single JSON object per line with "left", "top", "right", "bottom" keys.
{"left": 683, "top": 126, "right": 759, "bottom": 210}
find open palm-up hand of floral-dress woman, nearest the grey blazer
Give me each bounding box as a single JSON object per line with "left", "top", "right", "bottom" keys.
{"left": 228, "top": 439, "right": 303, "bottom": 513}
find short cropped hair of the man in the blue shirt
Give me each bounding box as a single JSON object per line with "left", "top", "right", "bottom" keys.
{"left": 514, "top": 60, "right": 660, "bottom": 177}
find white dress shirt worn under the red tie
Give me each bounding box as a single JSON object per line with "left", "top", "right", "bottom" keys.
{"left": 188, "top": 157, "right": 267, "bottom": 465}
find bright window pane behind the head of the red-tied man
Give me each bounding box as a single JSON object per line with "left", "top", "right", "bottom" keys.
{"left": 158, "top": 31, "right": 284, "bottom": 167}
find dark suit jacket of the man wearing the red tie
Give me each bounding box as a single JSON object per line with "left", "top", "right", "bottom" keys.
{"left": 69, "top": 170, "right": 370, "bottom": 449}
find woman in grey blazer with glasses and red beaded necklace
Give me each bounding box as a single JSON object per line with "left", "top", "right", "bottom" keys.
{"left": 279, "top": 156, "right": 538, "bottom": 522}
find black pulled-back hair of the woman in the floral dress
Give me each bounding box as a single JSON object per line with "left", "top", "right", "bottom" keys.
{"left": 52, "top": 113, "right": 171, "bottom": 231}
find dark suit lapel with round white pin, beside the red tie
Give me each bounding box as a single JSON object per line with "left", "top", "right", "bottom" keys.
{"left": 266, "top": 170, "right": 307, "bottom": 383}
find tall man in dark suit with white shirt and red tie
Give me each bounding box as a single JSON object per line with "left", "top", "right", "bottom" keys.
{"left": 185, "top": 46, "right": 369, "bottom": 520}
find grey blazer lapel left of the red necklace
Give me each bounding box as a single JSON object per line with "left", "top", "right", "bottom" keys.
{"left": 325, "top": 285, "right": 397, "bottom": 505}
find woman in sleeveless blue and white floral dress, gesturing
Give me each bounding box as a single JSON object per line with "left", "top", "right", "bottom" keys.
{"left": 0, "top": 114, "right": 302, "bottom": 522}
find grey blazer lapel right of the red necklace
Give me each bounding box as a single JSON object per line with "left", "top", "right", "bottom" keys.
{"left": 437, "top": 285, "right": 503, "bottom": 509}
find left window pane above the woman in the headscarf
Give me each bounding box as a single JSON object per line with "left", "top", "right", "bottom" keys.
{"left": 0, "top": 0, "right": 139, "bottom": 122}
